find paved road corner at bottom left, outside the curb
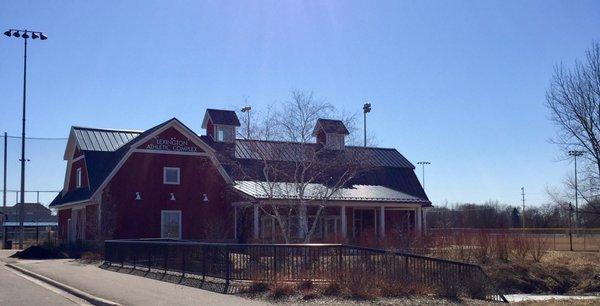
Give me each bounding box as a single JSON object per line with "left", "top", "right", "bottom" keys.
{"left": 0, "top": 263, "right": 83, "bottom": 306}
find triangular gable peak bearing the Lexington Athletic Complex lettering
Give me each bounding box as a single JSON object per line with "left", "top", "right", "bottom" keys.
{"left": 137, "top": 127, "right": 205, "bottom": 153}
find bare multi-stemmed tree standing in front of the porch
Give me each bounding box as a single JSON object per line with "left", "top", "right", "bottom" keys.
{"left": 234, "top": 90, "right": 369, "bottom": 243}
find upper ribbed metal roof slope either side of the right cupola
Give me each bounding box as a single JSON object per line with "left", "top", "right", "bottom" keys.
{"left": 235, "top": 139, "right": 415, "bottom": 169}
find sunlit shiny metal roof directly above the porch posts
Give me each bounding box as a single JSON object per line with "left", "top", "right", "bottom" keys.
{"left": 234, "top": 181, "right": 429, "bottom": 204}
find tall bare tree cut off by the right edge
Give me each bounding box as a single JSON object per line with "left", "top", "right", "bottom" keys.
{"left": 546, "top": 42, "right": 600, "bottom": 213}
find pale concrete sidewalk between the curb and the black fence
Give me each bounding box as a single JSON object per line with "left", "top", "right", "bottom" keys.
{"left": 13, "top": 259, "right": 267, "bottom": 305}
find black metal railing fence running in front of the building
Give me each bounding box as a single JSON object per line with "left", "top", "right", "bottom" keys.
{"left": 105, "top": 239, "right": 506, "bottom": 302}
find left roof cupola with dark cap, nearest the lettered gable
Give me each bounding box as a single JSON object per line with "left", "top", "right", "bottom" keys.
{"left": 202, "top": 108, "right": 240, "bottom": 142}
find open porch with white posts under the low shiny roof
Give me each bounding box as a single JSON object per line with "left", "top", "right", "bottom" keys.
{"left": 234, "top": 201, "right": 425, "bottom": 242}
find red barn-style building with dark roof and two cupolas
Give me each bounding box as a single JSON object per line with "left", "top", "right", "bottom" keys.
{"left": 50, "top": 109, "right": 431, "bottom": 242}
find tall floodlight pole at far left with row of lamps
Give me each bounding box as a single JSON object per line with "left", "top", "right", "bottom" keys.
{"left": 4, "top": 29, "right": 48, "bottom": 249}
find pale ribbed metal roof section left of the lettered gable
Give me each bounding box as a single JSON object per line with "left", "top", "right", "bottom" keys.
{"left": 73, "top": 127, "right": 142, "bottom": 152}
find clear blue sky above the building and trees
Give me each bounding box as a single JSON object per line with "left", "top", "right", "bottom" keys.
{"left": 0, "top": 1, "right": 600, "bottom": 205}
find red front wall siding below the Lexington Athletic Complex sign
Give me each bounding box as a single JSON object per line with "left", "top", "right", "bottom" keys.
{"left": 102, "top": 153, "right": 234, "bottom": 239}
